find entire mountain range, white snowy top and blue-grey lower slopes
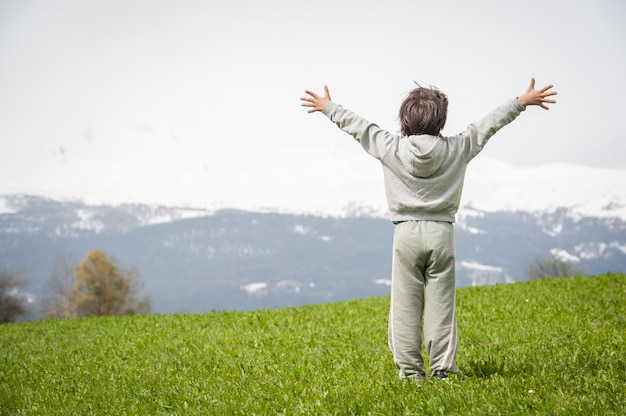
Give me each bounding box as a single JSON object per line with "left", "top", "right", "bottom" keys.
{"left": 0, "top": 132, "right": 626, "bottom": 312}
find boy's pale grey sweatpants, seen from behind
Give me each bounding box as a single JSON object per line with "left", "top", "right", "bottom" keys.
{"left": 389, "top": 221, "right": 458, "bottom": 379}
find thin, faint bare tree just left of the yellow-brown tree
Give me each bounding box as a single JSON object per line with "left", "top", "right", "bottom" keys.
{"left": 42, "top": 256, "right": 78, "bottom": 319}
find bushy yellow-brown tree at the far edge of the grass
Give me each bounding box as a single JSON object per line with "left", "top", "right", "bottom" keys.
{"left": 72, "top": 250, "right": 151, "bottom": 316}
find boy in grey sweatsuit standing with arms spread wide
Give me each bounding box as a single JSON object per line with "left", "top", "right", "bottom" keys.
{"left": 301, "top": 78, "right": 556, "bottom": 380}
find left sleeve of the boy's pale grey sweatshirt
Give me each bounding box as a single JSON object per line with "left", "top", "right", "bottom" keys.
{"left": 322, "top": 101, "right": 398, "bottom": 160}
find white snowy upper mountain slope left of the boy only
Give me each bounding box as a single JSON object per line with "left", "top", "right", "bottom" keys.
{"left": 0, "top": 129, "right": 385, "bottom": 216}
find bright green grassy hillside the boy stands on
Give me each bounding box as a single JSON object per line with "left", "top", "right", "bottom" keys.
{"left": 0, "top": 274, "right": 626, "bottom": 415}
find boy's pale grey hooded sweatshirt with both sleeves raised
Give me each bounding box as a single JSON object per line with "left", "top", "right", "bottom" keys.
{"left": 322, "top": 98, "right": 524, "bottom": 223}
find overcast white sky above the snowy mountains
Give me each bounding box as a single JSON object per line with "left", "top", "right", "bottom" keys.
{"left": 0, "top": 0, "right": 626, "bottom": 208}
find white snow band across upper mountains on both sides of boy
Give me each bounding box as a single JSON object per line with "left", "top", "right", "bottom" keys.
{"left": 0, "top": 122, "right": 626, "bottom": 221}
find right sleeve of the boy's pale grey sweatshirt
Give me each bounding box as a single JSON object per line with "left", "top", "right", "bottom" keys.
{"left": 461, "top": 98, "right": 525, "bottom": 162}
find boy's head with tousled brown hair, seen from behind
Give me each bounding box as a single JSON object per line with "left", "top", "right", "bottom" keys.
{"left": 399, "top": 87, "right": 448, "bottom": 136}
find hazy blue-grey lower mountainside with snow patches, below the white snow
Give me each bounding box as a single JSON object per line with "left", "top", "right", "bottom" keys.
{"left": 0, "top": 195, "right": 626, "bottom": 313}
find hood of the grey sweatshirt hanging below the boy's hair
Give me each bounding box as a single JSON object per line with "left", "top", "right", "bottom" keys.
{"left": 398, "top": 134, "right": 447, "bottom": 178}
